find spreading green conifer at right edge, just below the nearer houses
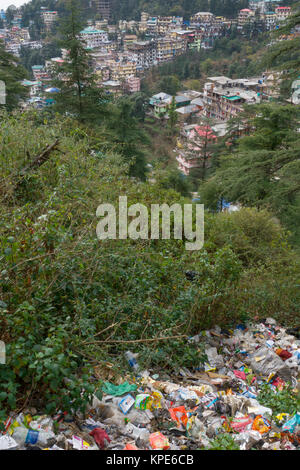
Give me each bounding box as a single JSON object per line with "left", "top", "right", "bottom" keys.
{"left": 200, "top": 104, "right": 300, "bottom": 241}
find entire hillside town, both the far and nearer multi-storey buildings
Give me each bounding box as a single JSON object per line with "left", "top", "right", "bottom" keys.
{"left": 0, "top": 0, "right": 300, "bottom": 175}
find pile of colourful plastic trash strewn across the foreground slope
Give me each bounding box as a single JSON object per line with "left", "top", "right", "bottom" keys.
{"left": 0, "top": 318, "right": 300, "bottom": 451}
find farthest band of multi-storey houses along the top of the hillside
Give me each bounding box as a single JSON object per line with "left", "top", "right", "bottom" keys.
{"left": 0, "top": 0, "right": 290, "bottom": 98}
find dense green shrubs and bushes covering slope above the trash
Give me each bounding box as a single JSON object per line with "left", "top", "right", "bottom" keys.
{"left": 0, "top": 109, "right": 299, "bottom": 422}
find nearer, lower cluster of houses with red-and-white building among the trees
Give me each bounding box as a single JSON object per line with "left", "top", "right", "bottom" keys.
{"left": 149, "top": 72, "right": 290, "bottom": 175}
